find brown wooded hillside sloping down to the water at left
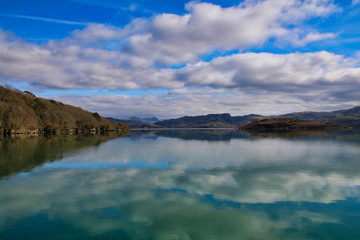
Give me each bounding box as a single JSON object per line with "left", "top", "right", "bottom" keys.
{"left": 0, "top": 86, "right": 129, "bottom": 135}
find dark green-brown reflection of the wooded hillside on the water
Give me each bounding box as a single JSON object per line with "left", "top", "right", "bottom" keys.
{"left": 0, "top": 133, "right": 129, "bottom": 179}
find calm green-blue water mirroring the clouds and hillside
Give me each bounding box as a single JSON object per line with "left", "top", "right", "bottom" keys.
{"left": 0, "top": 131, "right": 360, "bottom": 240}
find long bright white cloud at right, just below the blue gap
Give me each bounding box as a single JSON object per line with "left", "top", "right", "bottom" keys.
{"left": 177, "top": 51, "right": 360, "bottom": 92}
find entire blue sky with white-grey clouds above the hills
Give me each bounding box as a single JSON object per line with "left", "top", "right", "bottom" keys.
{"left": 0, "top": 0, "right": 360, "bottom": 119}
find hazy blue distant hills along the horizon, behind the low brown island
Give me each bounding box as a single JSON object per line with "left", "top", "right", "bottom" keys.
{"left": 111, "top": 106, "right": 360, "bottom": 128}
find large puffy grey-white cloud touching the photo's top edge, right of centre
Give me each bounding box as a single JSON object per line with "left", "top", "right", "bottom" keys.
{"left": 123, "top": 0, "right": 338, "bottom": 65}
